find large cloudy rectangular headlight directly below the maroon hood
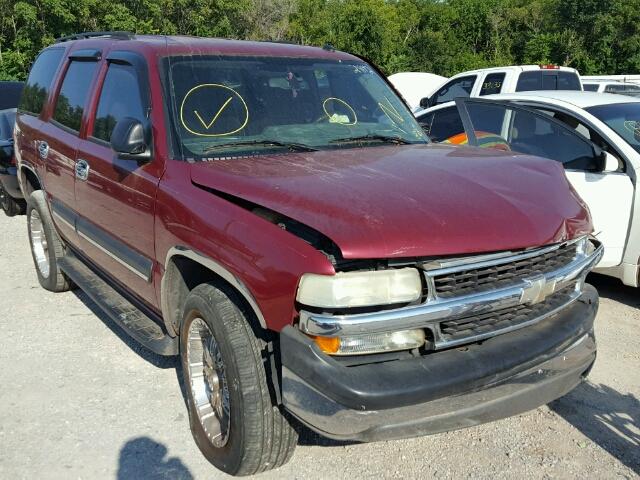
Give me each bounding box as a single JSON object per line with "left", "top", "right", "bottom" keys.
{"left": 297, "top": 268, "right": 422, "bottom": 308}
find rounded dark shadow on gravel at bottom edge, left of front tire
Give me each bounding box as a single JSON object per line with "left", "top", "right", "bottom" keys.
{"left": 117, "top": 437, "right": 193, "bottom": 480}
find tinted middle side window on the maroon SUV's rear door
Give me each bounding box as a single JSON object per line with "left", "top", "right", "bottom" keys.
{"left": 53, "top": 61, "right": 98, "bottom": 132}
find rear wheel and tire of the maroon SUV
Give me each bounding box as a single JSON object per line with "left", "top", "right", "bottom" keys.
{"left": 27, "top": 190, "right": 72, "bottom": 292}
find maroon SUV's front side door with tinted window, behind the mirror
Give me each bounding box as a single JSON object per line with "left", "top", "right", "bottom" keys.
{"left": 76, "top": 51, "right": 163, "bottom": 306}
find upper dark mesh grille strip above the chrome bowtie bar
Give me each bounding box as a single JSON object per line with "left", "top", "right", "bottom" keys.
{"left": 433, "top": 243, "right": 577, "bottom": 298}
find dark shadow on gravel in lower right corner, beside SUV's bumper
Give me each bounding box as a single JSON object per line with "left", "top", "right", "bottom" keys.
{"left": 549, "top": 382, "right": 640, "bottom": 473}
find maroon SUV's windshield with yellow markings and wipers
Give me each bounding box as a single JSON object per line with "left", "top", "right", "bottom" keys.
{"left": 165, "top": 56, "right": 428, "bottom": 160}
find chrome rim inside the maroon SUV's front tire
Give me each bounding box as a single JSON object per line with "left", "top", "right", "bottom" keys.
{"left": 187, "top": 317, "right": 230, "bottom": 448}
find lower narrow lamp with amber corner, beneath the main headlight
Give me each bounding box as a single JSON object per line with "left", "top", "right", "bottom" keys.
{"left": 313, "top": 329, "right": 425, "bottom": 355}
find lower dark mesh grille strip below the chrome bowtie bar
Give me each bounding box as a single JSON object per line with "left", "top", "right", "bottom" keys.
{"left": 440, "top": 283, "right": 576, "bottom": 342}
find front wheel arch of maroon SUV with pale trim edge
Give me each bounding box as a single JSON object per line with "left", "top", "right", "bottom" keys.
{"left": 160, "top": 247, "right": 267, "bottom": 335}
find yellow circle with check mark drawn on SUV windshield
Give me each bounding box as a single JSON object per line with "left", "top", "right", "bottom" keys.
{"left": 180, "top": 83, "right": 249, "bottom": 137}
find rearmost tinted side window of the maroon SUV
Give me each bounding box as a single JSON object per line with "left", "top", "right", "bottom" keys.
{"left": 18, "top": 48, "right": 64, "bottom": 115}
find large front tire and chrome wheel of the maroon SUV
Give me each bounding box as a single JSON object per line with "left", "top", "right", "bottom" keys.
{"left": 180, "top": 283, "right": 298, "bottom": 475}
